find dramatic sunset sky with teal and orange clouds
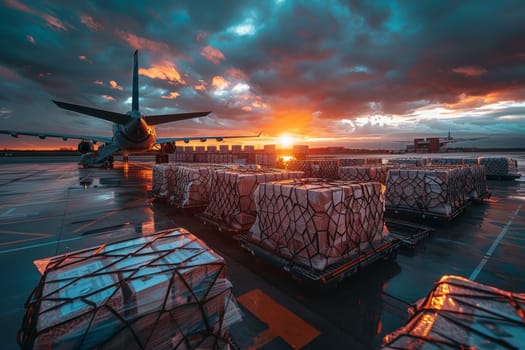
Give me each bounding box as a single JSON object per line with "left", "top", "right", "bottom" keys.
{"left": 0, "top": 0, "right": 525, "bottom": 148}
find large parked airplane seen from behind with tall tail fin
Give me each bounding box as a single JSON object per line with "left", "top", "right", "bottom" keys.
{"left": 0, "top": 50, "right": 261, "bottom": 167}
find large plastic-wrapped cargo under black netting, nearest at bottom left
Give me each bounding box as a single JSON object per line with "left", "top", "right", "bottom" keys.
{"left": 18, "top": 229, "right": 241, "bottom": 350}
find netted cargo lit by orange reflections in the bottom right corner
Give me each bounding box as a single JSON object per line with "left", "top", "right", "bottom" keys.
{"left": 383, "top": 276, "right": 525, "bottom": 349}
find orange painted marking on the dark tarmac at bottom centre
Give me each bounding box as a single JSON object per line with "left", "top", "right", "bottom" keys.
{"left": 237, "top": 289, "right": 321, "bottom": 349}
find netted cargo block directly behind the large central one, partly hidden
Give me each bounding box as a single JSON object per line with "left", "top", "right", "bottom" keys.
{"left": 203, "top": 169, "right": 304, "bottom": 231}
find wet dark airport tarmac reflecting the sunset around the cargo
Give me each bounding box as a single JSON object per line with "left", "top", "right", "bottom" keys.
{"left": 0, "top": 158, "right": 525, "bottom": 349}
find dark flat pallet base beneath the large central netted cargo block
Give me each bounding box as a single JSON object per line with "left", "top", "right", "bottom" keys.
{"left": 237, "top": 235, "right": 401, "bottom": 286}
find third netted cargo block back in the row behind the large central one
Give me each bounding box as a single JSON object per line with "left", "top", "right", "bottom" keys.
{"left": 169, "top": 164, "right": 229, "bottom": 208}
